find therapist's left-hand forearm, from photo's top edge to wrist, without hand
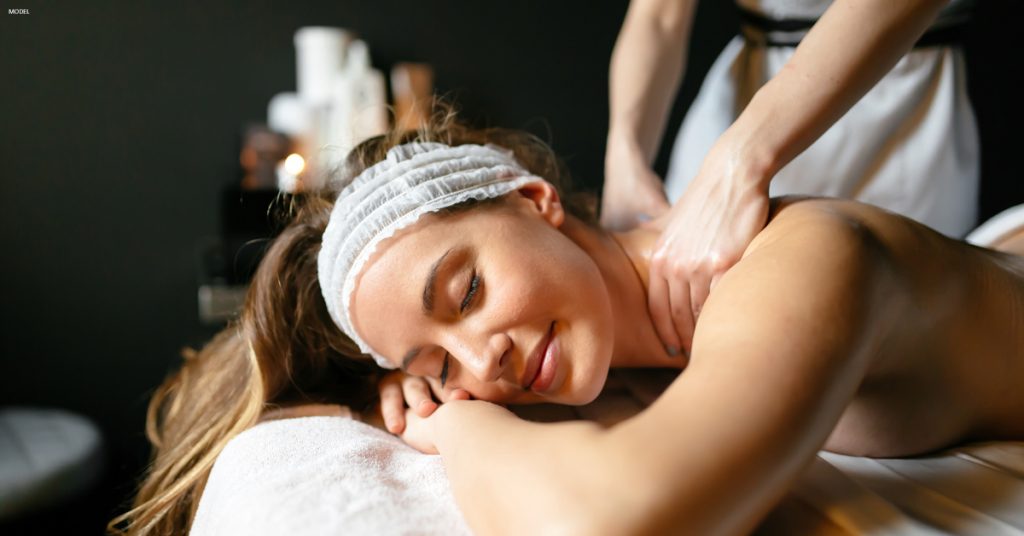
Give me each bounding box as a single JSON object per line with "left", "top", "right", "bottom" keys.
{"left": 608, "top": 0, "right": 696, "bottom": 162}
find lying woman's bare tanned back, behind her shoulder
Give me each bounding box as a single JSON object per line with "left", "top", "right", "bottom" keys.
{"left": 744, "top": 200, "right": 1024, "bottom": 456}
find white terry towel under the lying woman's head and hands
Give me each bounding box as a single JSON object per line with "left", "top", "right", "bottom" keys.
{"left": 190, "top": 417, "right": 469, "bottom": 536}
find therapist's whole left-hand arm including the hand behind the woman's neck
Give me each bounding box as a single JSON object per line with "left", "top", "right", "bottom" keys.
{"left": 601, "top": 0, "right": 696, "bottom": 229}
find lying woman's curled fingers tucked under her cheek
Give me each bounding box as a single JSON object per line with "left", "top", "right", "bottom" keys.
{"left": 378, "top": 370, "right": 470, "bottom": 435}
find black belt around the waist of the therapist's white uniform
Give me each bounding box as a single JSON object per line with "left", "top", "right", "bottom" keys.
{"left": 739, "top": 7, "right": 969, "bottom": 48}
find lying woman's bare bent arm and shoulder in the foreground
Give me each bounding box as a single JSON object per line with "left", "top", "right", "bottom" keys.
{"left": 435, "top": 203, "right": 898, "bottom": 534}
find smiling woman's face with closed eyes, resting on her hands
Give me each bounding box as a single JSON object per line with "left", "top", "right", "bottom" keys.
{"left": 352, "top": 183, "right": 613, "bottom": 405}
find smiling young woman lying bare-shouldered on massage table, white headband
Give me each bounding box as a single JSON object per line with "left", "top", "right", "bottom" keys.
{"left": 112, "top": 113, "right": 1024, "bottom": 534}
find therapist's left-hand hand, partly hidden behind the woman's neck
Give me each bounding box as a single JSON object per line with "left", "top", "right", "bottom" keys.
{"left": 601, "top": 140, "right": 670, "bottom": 231}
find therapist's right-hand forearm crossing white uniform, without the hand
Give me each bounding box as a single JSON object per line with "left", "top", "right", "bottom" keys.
{"left": 724, "top": 0, "right": 946, "bottom": 190}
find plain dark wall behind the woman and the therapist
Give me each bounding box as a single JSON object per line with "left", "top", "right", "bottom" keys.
{"left": 0, "top": 0, "right": 1024, "bottom": 534}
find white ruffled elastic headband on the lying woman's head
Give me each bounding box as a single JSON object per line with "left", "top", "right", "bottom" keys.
{"left": 316, "top": 142, "right": 543, "bottom": 369}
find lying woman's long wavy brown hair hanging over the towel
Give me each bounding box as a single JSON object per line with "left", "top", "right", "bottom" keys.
{"left": 108, "top": 101, "right": 596, "bottom": 535}
